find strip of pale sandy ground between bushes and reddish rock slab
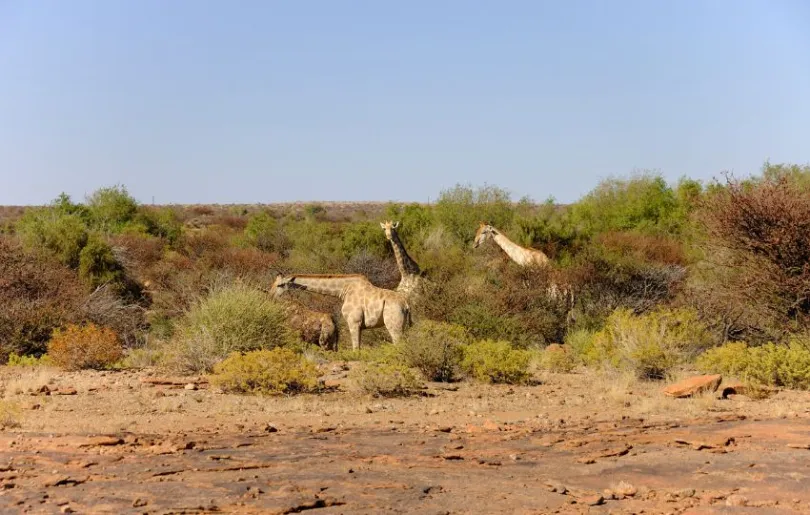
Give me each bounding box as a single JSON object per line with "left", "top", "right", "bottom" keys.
{"left": 0, "top": 367, "right": 810, "bottom": 440}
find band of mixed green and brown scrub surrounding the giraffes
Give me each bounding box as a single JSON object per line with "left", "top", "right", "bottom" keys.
{"left": 0, "top": 163, "right": 810, "bottom": 396}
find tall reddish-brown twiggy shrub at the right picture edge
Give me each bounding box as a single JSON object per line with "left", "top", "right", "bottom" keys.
{"left": 690, "top": 175, "right": 810, "bottom": 341}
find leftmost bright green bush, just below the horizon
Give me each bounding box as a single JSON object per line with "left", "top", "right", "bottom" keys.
{"left": 16, "top": 208, "right": 88, "bottom": 268}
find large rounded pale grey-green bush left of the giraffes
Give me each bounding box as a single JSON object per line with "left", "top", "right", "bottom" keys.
{"left": 165, "top": 283, "right": 301, "bottom": 372}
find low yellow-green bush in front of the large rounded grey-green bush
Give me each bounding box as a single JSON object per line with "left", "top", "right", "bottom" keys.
{"left": 211, "top": 348, "right": 319, "bottom": 394}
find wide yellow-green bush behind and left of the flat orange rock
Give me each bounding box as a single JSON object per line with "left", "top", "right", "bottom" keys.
{"left": 584, "top": 308, "right": 711, "bottom": 379}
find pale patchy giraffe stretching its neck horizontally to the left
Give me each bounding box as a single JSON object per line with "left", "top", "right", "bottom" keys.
{"left": 270, "top": 274, "right": 411, "bottom": 350}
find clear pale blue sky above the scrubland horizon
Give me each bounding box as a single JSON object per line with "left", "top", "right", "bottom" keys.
{"left": 0, "top": 0, "right": 810, "bottom": 204}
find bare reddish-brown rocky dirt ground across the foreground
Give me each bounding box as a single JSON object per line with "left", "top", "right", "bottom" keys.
{"left": 0, "top": 365, "right": 810, "bottom": 514}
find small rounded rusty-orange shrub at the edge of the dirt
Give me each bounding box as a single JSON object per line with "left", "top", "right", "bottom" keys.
{"left": 48, "top": 323, "right": 124, "bottom": 370}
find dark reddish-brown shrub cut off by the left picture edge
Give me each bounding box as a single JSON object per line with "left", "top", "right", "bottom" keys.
{"left": 0, "top": 238, "right": 82, "bottom": 361}
